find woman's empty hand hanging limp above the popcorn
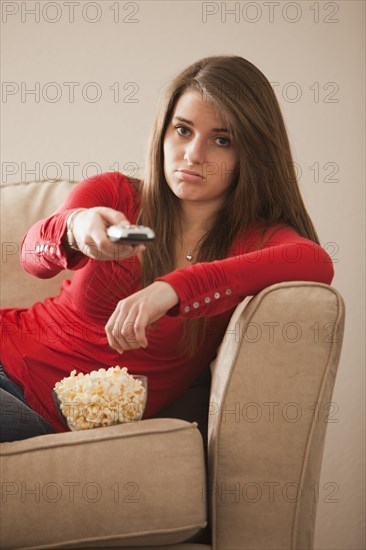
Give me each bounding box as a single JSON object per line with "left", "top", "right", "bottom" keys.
{"left": 105, "top": 281, "right": 179, "bottom": 353}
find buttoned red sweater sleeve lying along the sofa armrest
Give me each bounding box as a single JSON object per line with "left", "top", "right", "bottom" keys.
{"left": 156, "top": 228, "right": 334, "bottom": 318}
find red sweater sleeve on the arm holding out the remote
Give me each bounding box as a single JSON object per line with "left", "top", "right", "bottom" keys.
{"left": 20, "top": 172, "right": 134, "bottom": 279}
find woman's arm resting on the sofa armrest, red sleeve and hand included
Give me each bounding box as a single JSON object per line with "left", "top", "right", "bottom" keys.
{"left": 105, "top": 229, "right": 334, "bottom": 353}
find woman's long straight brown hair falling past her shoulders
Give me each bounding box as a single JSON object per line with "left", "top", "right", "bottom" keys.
{"left": 138, "top": 55, "right": 320, "bottom": 355}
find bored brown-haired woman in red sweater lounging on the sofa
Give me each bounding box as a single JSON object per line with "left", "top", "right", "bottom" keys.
{"left": 1, "top": 56, "right": 334, "bottom": 441}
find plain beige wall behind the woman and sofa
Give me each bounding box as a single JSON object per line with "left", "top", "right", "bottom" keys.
{"left": 1, "top": 0, "right": 365, "bottom": 550}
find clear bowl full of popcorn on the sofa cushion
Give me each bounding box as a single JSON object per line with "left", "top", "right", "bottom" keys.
{"left": 53, "top": 366, "right": 147, "bottom": 431}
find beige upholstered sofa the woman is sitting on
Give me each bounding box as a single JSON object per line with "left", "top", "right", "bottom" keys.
{"left": 0, "top": 181, "right": 345, "bottom": 550}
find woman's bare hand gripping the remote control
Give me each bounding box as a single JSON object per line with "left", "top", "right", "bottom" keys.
{"left": 68, "top": 206, "right": 145, "bottom": 260}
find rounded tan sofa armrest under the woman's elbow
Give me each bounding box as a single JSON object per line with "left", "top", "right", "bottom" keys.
{"left": 208, "top": 281, "right": 345, "bottom": 550}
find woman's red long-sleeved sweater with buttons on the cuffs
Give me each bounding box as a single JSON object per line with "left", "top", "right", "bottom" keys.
{"left": 0, "top": 172, "right": 334, "bottom": 431}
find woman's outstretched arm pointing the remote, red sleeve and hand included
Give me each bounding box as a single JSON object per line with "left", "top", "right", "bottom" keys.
{"left": 21, "top": 172, "right": 142, "bottom": 279}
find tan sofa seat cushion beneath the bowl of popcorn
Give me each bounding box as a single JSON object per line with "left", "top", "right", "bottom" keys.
{"left": 0, "top": 418, "right": 206, "bottom": 549}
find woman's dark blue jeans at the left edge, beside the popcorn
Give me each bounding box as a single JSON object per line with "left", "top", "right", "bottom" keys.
{"left": 0, "top": 365, "right": 56, "bottom": 443}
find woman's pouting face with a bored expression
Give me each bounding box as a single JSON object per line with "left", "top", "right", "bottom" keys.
{"left": 164, "top": 91, "right": 239, "bottom": 208}
